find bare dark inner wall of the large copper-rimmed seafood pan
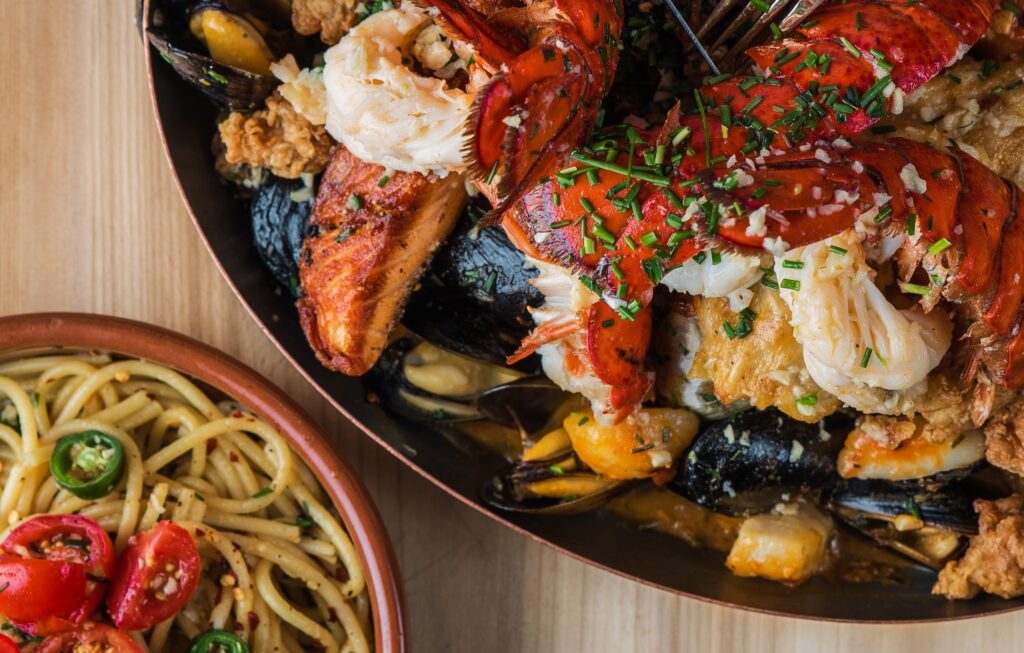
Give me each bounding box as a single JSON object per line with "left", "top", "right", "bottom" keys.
{"left": 145, "top": 2, "right": 1024, "bottom": 622}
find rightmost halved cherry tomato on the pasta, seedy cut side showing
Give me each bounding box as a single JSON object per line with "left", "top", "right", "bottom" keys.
{"left": 106, "top": 522, "right": 200, "bottom": 630}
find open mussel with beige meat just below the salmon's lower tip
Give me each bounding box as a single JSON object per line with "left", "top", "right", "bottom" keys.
{"left": 369, "top": 338, "right": 569, "bottom": 433}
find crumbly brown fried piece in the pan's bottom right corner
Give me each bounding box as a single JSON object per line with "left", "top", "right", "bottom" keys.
{"left": 932, "top": 494, "right": 1024, "bottom": 599}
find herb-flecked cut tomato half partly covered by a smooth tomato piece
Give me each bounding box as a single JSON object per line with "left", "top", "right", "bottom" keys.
{"left": 0, "top": 515, "right": 115, "bottom": 636}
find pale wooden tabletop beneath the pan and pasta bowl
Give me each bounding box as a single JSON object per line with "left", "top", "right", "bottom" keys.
{"left": 0, "top": 0, "right": 1024, "bottom": 653}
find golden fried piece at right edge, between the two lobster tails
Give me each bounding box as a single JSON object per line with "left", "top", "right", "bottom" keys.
{"left": 903, "top": 58, "right": 1024, "bottom": 184}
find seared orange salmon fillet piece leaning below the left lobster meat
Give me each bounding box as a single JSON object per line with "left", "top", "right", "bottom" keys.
{"left": 298, "top": 145, "right": 466, "bottom": 376}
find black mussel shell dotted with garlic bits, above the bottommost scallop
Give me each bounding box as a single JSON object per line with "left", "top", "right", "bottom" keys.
{"left": 672, "top": 410, "right": 842, "bottom": 515}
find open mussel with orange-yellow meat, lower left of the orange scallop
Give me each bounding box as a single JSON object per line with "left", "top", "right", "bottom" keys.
{"left": 483, "top": 429, "right": 631, "bottom": 515}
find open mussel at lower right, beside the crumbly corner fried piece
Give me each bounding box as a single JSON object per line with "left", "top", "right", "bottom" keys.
{"left": 828, "top": 479, "right": 978, "bottom": 569}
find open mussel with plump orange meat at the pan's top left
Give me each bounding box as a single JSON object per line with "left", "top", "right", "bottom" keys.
{"left": 147, "top": 0, "right": 280, "bottom": 111}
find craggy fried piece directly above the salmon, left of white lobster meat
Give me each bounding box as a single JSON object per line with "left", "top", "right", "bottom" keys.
{"left": 220, "top": 92, "right": 334, "bottom": 179}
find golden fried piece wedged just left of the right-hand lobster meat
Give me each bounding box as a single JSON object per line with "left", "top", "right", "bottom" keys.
{"left": 690, "top": 285, "right": 840, "bottom": 423}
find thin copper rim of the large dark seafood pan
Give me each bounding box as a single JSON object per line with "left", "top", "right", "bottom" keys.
{"left": 137, "top": 6, "right": 1024, "bottom": 625}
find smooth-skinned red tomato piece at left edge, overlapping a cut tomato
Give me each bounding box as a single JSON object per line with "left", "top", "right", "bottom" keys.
{"left": 0, "top": 557, "right": 85, "bottom": 621}
